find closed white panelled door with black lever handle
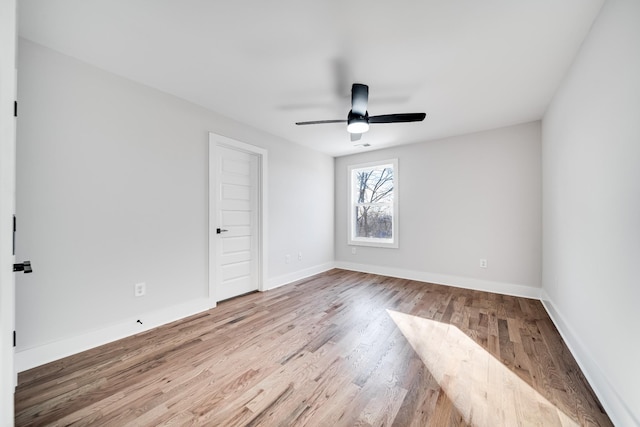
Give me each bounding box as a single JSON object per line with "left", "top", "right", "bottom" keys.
{"left": 209, "top": 135, "right": 263, "bottom": 301}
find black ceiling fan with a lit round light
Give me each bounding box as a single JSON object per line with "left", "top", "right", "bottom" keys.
{"left": 296, "top": 83, "right": 426, "bottom": 141}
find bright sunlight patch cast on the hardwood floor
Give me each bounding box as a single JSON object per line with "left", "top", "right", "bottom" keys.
{"left": 387, "top": 310, "right": 578, "bottom": 427}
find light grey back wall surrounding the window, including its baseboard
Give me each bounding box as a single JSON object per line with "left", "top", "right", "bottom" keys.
{"left": 335, "top": 122, "right": 542, "bottom": 297}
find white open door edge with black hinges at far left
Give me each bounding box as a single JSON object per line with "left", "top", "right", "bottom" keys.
{"left": 0, "top": 0, "right": 16, "bottom": 426}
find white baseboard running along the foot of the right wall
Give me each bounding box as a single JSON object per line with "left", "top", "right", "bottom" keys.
{"left": 540, "top": 289, "right": 640, "bottom": 427}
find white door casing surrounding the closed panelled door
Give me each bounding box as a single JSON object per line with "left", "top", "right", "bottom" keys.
{"left": 208, "top": 132, "right": 269, "bottom": 307}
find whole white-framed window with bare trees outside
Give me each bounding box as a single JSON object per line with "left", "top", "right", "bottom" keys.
{"left": 348, "top": 159, "right": 398, "bottom": 248}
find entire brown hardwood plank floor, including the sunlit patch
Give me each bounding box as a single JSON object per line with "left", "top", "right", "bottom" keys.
{"left": 15, "top": 270, "right": 611, "bottom": 427}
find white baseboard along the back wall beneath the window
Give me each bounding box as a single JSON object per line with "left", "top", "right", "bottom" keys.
{"left": 335, "top": 261, "right": 540, "bottom": 299}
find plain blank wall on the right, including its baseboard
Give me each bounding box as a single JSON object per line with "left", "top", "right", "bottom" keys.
{"left": 542, "top": 0, "right": 640, "bottom": 426}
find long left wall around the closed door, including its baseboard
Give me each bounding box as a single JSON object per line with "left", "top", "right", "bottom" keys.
{"left": 16, "top": 40, "right": 333, "bottom": 370}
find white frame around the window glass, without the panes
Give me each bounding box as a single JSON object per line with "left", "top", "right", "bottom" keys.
{"left": 347, "top": 159, "right": 399, "bottom": 248}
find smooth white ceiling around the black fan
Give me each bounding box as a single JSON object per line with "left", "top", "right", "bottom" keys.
{"left": 18, "top": 0, "right": 604, "bottom": 156}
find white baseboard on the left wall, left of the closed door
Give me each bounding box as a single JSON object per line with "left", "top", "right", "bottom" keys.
{"left": 14, "top": 298, "right": 211, "bottom": 372}
